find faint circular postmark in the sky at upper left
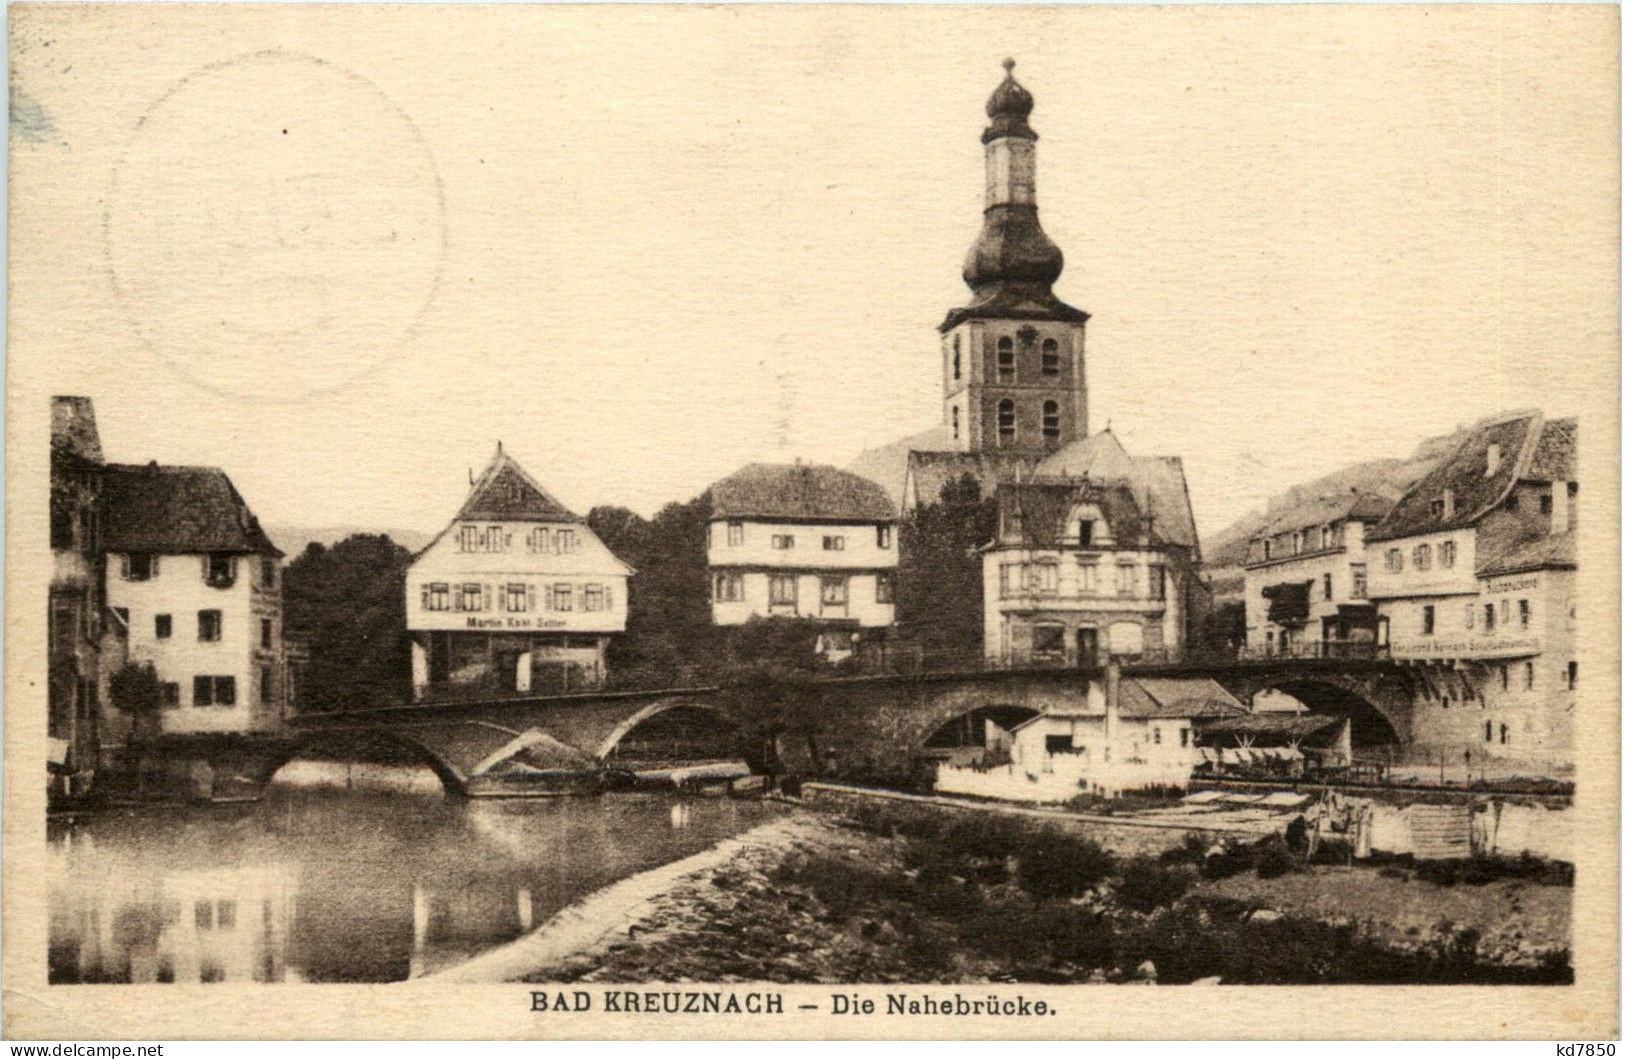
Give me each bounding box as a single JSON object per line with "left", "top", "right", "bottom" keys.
{"left": 102, "top": 50, "right": 445, "bottom": 401}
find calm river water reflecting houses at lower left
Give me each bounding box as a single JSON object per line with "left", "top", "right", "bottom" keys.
{"left": 49, "top": 778, "right": 774, "bottom": 983}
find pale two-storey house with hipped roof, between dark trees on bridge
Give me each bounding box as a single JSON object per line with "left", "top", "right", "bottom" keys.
{"left": 705, "top": 463, "right": 899, "bottom": 661}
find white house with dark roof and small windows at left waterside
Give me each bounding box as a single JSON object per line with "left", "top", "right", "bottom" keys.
{"left": 102, "top": 463, "right": 288, "bottom": 740}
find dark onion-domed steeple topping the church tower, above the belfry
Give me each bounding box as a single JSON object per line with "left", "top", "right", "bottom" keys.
{"left": 943, "top": 58, "right": 1089, "bottom": 331}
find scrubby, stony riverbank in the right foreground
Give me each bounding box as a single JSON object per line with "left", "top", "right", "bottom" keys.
{"left": 505, "top": 809, "right": 1571, "bottom": 984}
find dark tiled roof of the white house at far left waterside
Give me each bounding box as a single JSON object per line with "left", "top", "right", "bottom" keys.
{"left": 102, "top": 463, "right": 281, "bottom": 555}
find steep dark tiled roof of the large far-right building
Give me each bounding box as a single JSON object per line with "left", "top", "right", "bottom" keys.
{"left": 1367, "top": 411, "right": 1541, "bottom": 541}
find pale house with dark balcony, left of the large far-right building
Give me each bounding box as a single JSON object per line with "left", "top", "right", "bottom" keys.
{"left": 1243, "top": 491, "right": 1396, "bottom": 658}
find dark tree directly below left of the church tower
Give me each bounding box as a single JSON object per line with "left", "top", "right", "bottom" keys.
{"left": 897, "top": 474, "right": 998, "bottom": 658}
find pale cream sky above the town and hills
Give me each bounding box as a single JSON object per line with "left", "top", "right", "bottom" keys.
{"left": 8, "top": 5, "right": 1619, "bottom": 536}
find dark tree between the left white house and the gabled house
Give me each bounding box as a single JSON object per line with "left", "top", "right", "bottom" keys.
{"left": 283, "top": 533, "right": 411, "bottom": 710}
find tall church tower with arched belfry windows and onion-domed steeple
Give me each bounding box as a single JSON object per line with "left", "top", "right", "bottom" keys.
{"left": 938, "top": 58, "right": 1089, "bottom": 453}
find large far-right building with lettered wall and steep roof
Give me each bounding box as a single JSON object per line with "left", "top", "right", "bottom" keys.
{"left": 1367, "top": 411, "right": 1580, "bottom": 768}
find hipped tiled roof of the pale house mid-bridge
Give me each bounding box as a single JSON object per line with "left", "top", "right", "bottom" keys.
{"left": 710, "top": 463, "right": 897, "bottom": 521}
